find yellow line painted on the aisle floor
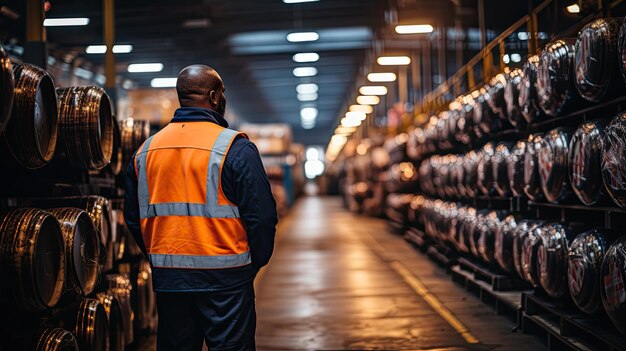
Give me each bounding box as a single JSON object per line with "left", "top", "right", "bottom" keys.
{"left": 389, "top": 261, "right": 480, "bottom": 344}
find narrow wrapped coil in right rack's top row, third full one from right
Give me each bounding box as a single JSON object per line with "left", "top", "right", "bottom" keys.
{"left": 517, "top": 55, "right": 543, "bottom": 123}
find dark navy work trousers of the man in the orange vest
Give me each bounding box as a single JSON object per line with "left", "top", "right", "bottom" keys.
{"left": 156, "top": 282, "right": 256, "bottom": 351}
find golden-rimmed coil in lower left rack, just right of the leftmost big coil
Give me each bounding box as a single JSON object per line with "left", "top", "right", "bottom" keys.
{"left": 50, "top": 207, "right": 100, "bottom": 295}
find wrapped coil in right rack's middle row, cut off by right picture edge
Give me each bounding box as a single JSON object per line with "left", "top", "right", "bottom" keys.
{"left": 602, "top": 112, "right": 626, "bottom": 207}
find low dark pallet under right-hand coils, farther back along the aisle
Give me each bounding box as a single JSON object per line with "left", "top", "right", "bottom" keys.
{"left": 450, "top": 264, "right": 523, "bottom": 324}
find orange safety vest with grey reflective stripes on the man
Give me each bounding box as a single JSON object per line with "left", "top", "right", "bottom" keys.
{"left": 135, "top": 122, "right": 251, "bottom": 269}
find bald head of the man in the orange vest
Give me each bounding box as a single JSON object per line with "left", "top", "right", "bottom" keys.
{"left": 176, "top": 65, "right": 226, "bottom": 115}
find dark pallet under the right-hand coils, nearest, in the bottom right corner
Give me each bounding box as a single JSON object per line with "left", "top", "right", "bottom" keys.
{"left": 519, "top": 293, "right": 626, "bottom": 351}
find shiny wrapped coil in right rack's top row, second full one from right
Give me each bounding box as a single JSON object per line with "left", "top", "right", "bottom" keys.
{"left": 537, "top": 38, "right": 577, "bottom": 116}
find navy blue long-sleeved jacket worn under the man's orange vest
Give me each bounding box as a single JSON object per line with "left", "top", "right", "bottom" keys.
{"left": 124, "top": 107, "right": 278, "bottom": 292}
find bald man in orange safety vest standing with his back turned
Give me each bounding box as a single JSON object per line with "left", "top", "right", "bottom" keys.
{"left": 124, "top": 65, "right": 277, "bottom": 351}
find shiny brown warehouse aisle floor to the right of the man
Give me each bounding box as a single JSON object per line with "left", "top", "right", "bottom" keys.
{"left": 256, "top": 197, "right": 543, "bottom": 351}
